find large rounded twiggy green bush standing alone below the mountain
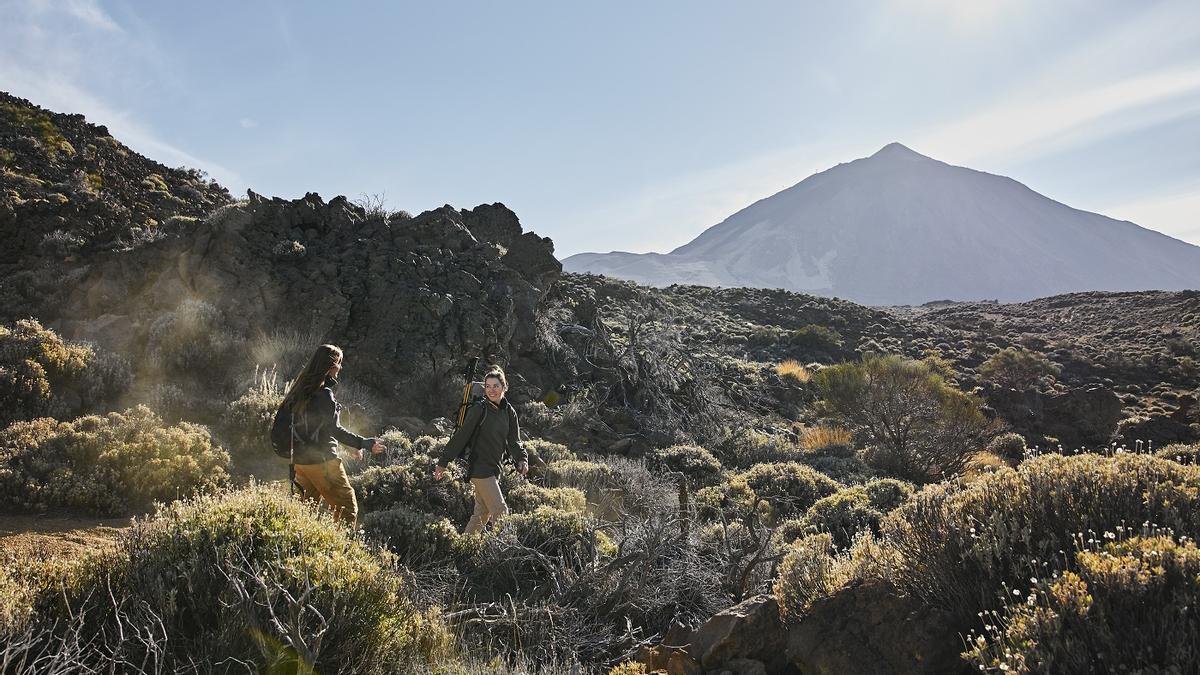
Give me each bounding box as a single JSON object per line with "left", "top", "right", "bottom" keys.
{"left": 814, "top": 356, "right": 995, "bottom": 482}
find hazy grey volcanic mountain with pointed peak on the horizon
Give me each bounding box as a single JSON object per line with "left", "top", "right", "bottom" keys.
{"left": 564, "top": 143, "right": 1200, "bottom": 304}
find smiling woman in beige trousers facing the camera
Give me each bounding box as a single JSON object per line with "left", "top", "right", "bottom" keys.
{"left": 433, "top": 365, "right": 529, "bottom": 534}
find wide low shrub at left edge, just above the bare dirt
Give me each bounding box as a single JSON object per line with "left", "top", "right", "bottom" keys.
{"left": 0, "top": 406, "right": 229, "bottom": 514}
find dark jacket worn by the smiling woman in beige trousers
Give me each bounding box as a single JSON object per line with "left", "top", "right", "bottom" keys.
{"left": 438, "top": 399, "right": 529, "bottom": 478}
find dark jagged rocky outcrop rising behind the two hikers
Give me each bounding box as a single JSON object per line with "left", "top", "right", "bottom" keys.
{"left": 23, "top": 192, "right": 559, "bottom": 417}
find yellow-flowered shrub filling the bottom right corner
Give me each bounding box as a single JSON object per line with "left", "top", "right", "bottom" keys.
{"left": 965, "top": 536, "right": 1200, "bottom": 673}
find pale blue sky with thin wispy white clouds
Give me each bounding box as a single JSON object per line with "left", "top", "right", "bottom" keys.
{"left": 0, "top": 0, "right": 1200, "bottom": 257}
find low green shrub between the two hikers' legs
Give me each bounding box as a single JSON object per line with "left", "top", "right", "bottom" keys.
{"left": 350, "top": 455, "right": 473, "bottom": 525}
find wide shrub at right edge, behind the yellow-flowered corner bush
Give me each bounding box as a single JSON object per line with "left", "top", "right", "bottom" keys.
{"left": 881, "top": 454, "right": 1200, "bottom": 631}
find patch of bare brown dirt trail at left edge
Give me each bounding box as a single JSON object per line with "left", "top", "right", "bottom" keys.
{"left": 0, "top": 514, "right": 130, "bottom": 560}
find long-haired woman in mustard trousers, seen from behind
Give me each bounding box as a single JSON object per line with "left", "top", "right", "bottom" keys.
{"left": 282, "top": 345, "right": 384, "bottom": 527}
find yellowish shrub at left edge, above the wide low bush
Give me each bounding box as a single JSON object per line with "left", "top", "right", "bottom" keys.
{"left": 0, "top": 318, "right": 95, "bottom": 426}
